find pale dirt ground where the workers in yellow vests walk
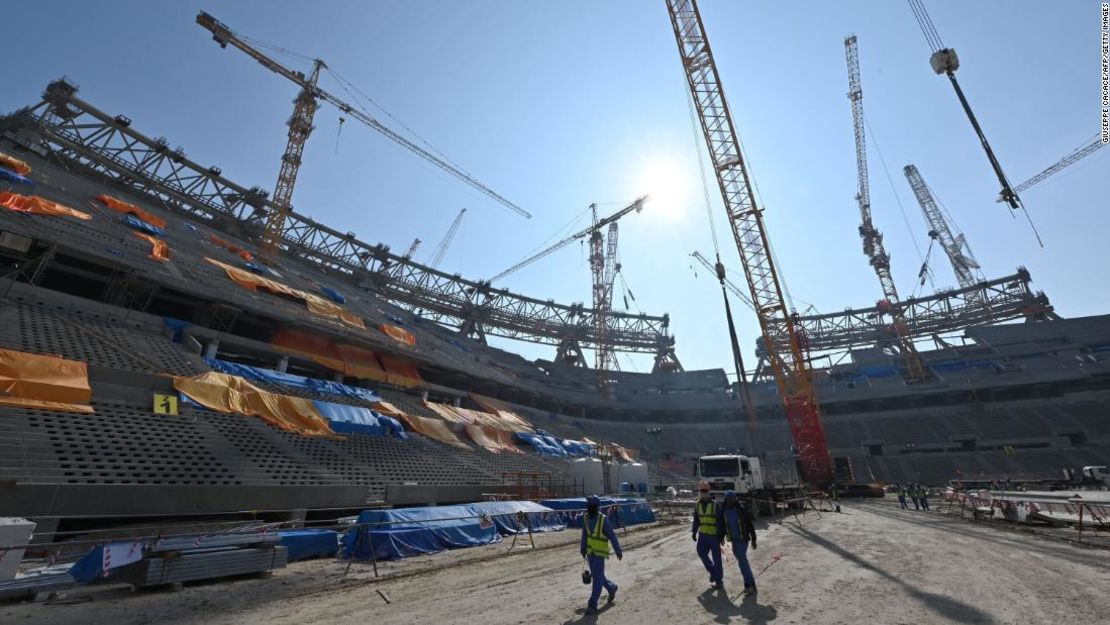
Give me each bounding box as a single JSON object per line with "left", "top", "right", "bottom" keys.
{"left": 0, "top": 500, "right": 1110, "bottom": 625}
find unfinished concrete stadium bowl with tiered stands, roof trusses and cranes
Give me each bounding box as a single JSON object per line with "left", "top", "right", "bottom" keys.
{"left": 0, "top": 0, "right": 1110, "bottom": 618}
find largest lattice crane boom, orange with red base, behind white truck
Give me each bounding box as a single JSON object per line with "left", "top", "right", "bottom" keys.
{"left": 666, "top": 0, "right": 833, "bottom": 484}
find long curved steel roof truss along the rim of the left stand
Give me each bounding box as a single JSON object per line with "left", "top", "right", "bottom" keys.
{"left": 0, "top": 80, "right": 675, "bottom": 355}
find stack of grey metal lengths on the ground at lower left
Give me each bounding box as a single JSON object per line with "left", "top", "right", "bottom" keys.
{"left": 112, "top": 546, "right": 289, "bottom": 587}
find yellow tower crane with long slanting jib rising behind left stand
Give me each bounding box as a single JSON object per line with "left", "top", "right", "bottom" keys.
{"left": 196, "top": 11, "right": 532, "bottom": 262}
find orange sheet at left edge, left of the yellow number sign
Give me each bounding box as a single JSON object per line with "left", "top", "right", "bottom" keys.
{"left": 0, "top": 350, "right": 92, "bottom": 413}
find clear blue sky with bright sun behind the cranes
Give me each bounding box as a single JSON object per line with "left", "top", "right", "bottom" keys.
{"left": 0, "top": 0, "right": 1110, "bottom": 371}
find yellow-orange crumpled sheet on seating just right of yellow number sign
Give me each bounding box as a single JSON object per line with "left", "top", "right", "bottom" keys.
{"left": 173, "top": 371, "right": 335, "bottom": 436}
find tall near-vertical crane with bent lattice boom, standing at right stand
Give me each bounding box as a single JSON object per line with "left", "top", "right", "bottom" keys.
{"left": 844, "top": 34, "right": 927, "bottom": 382}
